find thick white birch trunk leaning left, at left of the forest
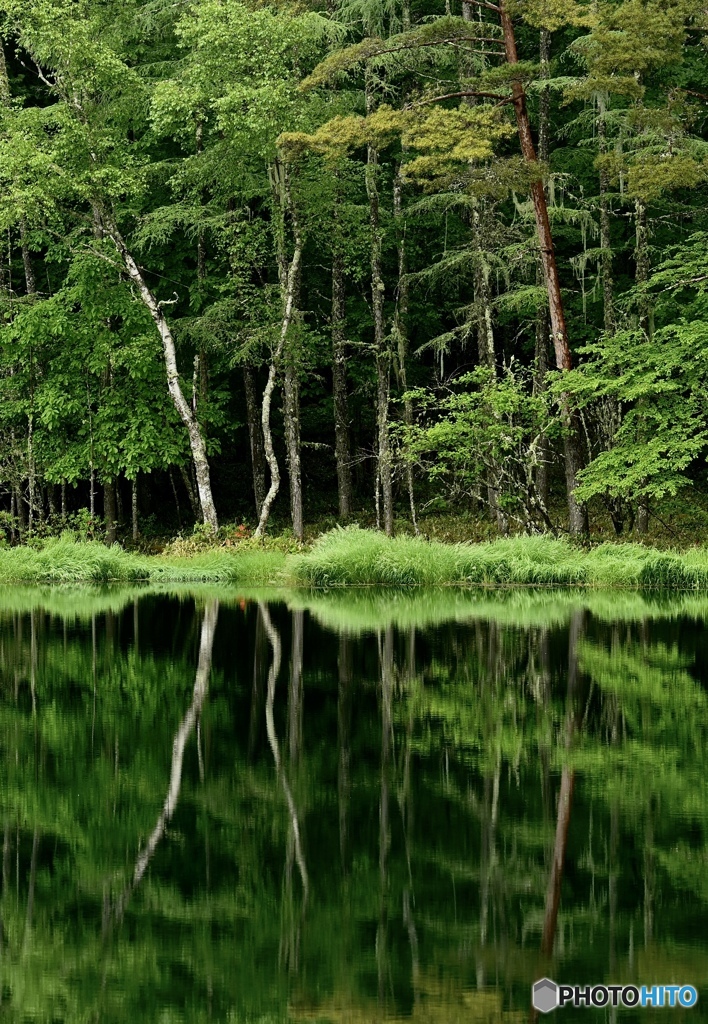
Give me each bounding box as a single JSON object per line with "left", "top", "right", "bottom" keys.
{"left": 101, "top": 211, "right": 218, "bottom": 532}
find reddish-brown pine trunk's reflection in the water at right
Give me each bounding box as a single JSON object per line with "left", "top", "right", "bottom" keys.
{"left": 541, "top": 611, "right": 583, "bottom": 956}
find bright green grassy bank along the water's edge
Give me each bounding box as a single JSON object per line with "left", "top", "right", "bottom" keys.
{"left": 0, "top": 528, "right": 708, "bottom": 591}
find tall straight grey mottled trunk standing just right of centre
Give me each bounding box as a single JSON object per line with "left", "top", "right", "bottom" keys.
{"left": 366, "top": 88, "right": 393, "bottom": 537}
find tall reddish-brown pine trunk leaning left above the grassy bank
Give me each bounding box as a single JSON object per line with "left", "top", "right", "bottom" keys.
{"left": 500, "top": 0, "right": 588, "bottom": 536}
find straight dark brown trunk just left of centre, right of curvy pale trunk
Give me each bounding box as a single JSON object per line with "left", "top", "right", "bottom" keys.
{"left": 332, "top": 210, "right": 352, "bottom": 522}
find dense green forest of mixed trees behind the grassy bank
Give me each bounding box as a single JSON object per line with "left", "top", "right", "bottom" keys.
{"left": 0, "top": 0, "right": 708, "bottom": 545}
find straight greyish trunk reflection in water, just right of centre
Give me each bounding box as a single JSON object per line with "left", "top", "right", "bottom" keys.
{"left": 376, "top": 626, "right": 393, "bottom": 1006}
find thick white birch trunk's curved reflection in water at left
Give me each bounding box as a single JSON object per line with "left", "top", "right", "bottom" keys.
{"left": 115, "top": 601, "right": 219, "bottom": 921}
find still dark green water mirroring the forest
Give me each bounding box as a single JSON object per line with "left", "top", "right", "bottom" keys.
{"left": 0, "top": 589, "right": 708, "bottom": 1024}
